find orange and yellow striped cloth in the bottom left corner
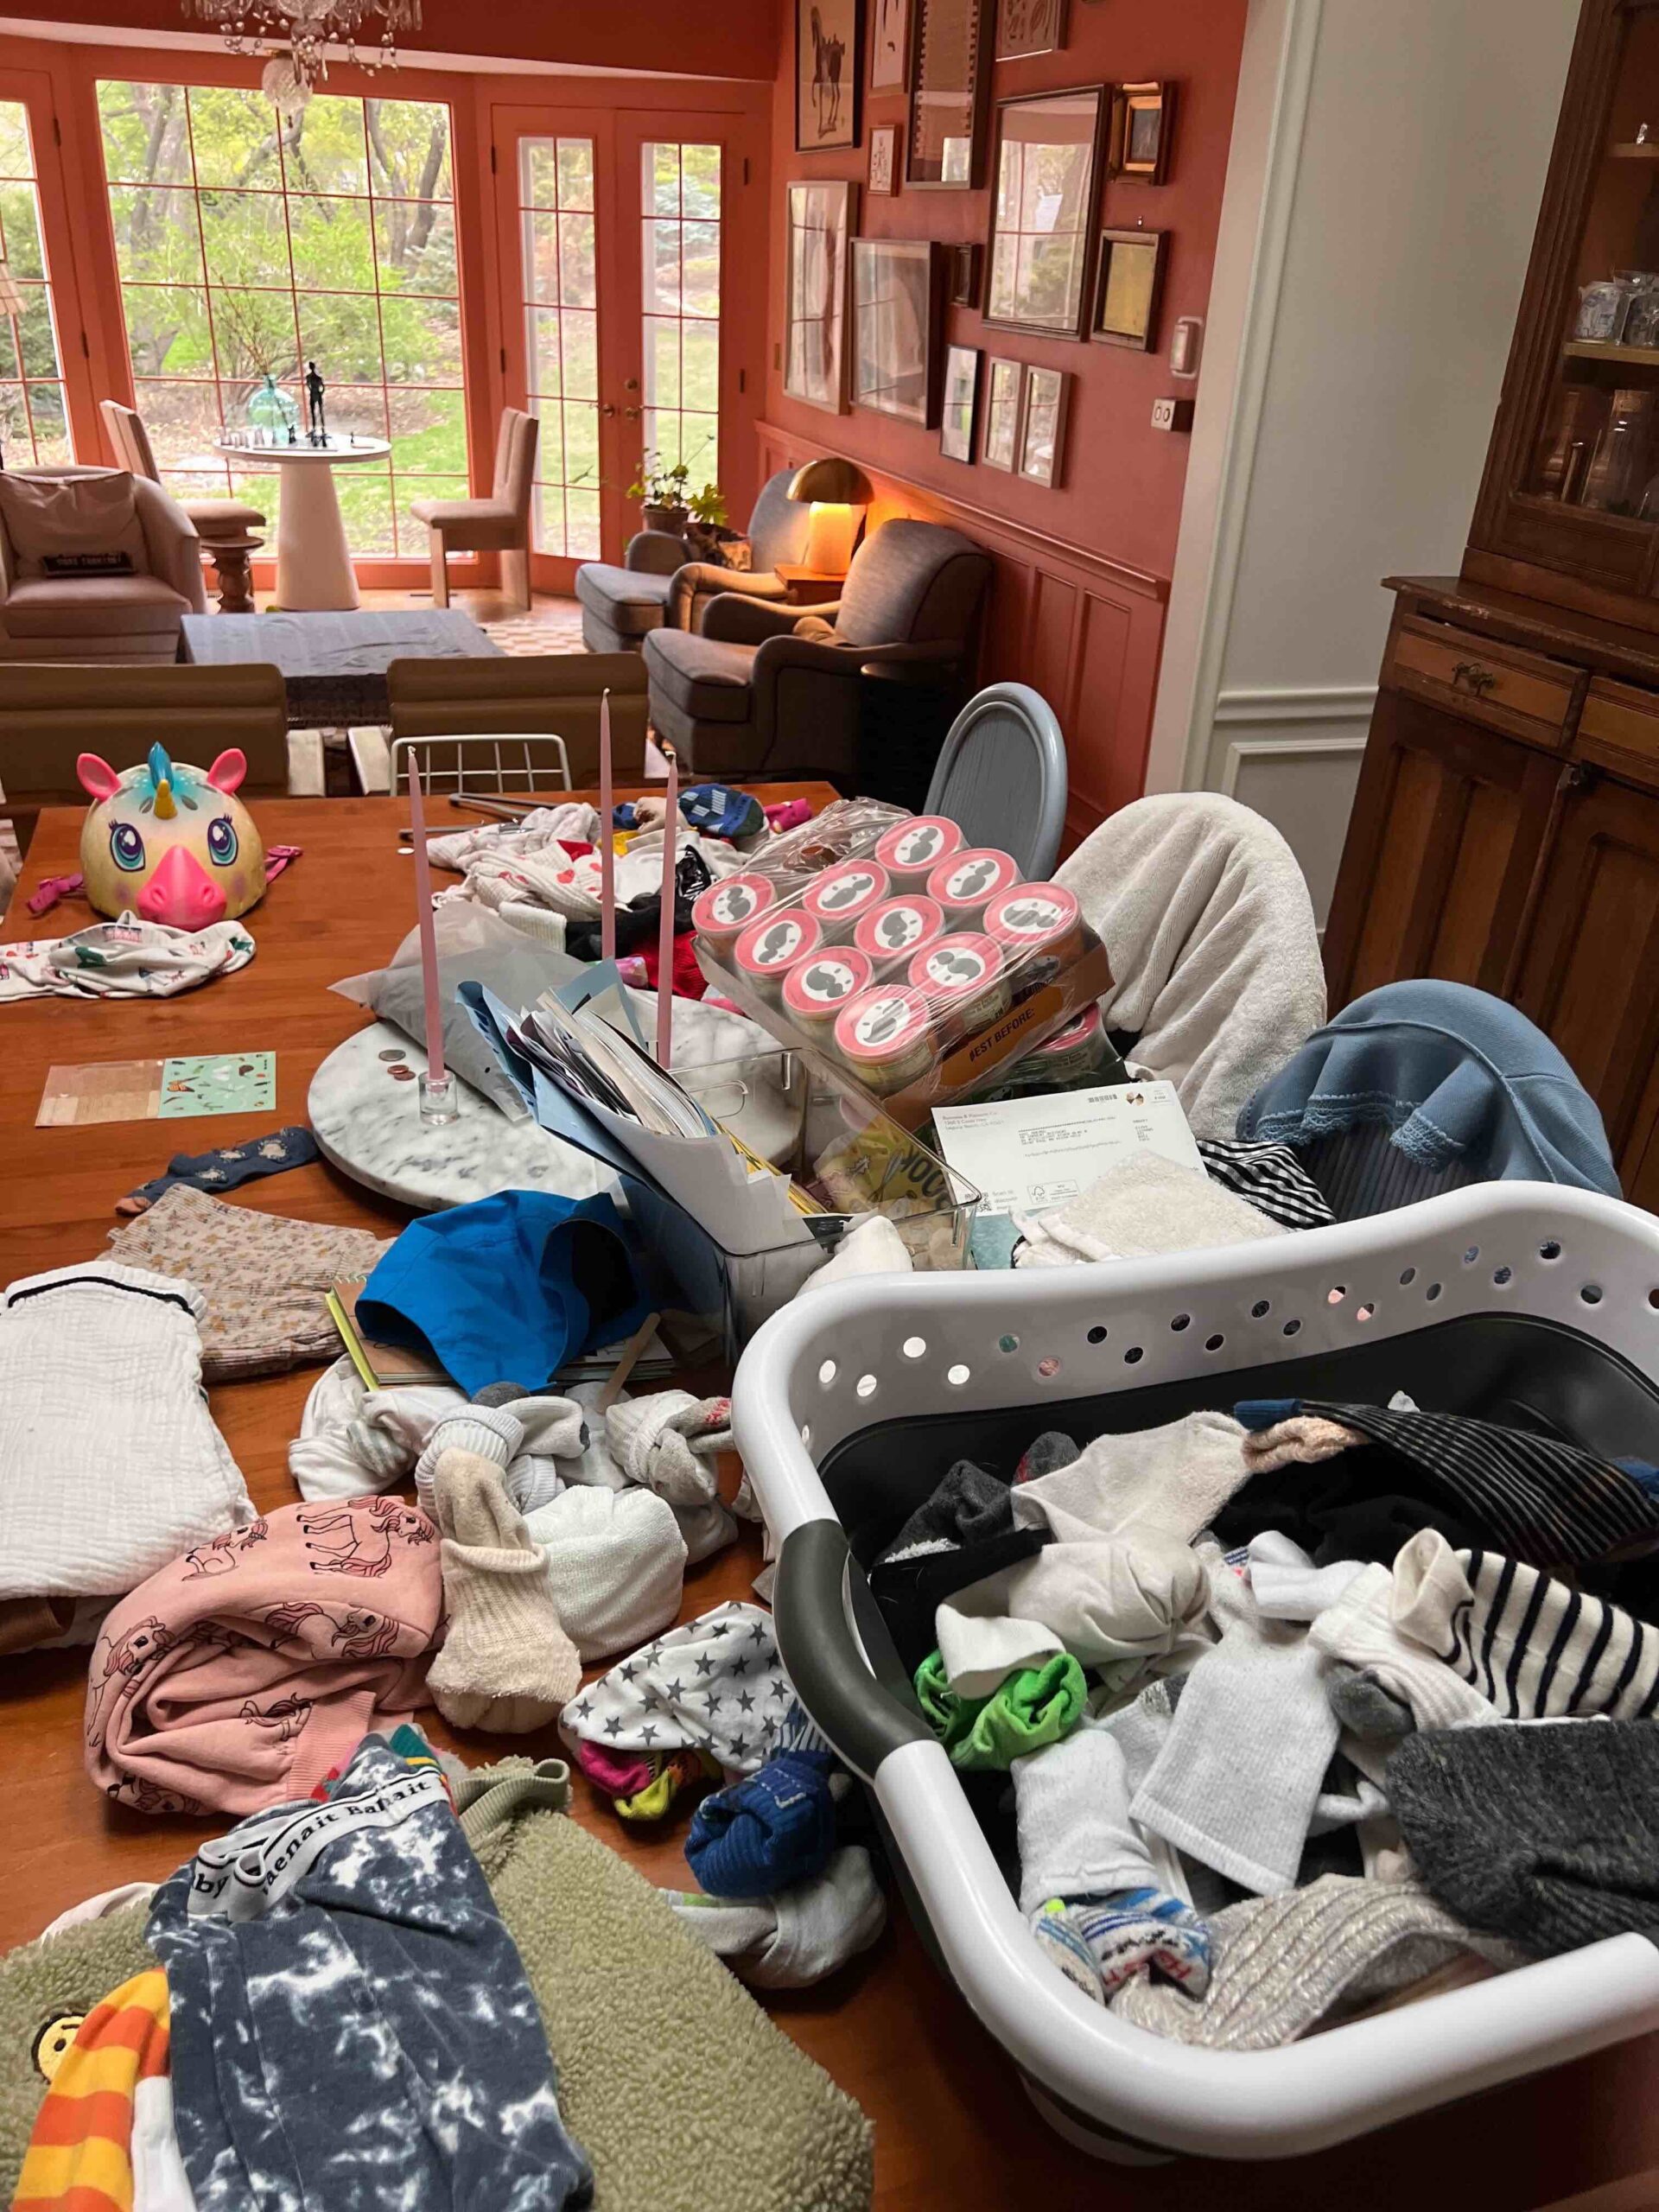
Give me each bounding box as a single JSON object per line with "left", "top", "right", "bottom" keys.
{"left": 11, "top": 1967, "right": 168, "bottom": 2212}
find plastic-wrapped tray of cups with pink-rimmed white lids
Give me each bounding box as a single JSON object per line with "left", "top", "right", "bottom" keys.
{"left": 696, "top": 840, "right": 1113, "bottom": 1130}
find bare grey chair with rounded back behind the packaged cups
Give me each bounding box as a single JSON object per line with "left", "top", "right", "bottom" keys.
{"left": 923, "top": 683, "right": 1066, "bottom": 882}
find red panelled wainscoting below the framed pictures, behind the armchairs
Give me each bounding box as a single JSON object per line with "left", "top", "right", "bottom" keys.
{"left": 759, "top": 423, "right": 1170, "bottom": 847}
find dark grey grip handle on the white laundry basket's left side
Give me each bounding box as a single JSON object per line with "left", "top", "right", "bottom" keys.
{"left": 772, "top": 1520, "right": 933, "bottom": 1781}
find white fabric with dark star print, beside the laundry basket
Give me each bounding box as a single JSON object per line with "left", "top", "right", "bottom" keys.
{"left": 560, "top": 1599, "right": 825, "bottom": 1774}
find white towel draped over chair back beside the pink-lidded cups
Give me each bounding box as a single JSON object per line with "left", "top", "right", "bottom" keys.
{"left": 1055, "top": 791, "right": 1325, "bottom": 1137}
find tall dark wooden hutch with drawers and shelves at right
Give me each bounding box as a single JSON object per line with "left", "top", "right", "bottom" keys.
{"left": 1325, "top": 0, "right": 1659, "bottom": 1210}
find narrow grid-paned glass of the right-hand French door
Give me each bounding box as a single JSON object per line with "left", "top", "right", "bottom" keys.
{"left": 639, "top": 143, "right": 721, "bottom": 491}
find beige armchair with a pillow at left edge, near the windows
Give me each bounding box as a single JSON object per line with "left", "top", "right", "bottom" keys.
{"left": 0, "top": 469, "right": 208, "bottom": 661}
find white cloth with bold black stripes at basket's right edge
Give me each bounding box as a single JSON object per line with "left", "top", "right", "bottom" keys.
{"left": 1394, "top": 1531, "right": 1659, "bottom": 1721}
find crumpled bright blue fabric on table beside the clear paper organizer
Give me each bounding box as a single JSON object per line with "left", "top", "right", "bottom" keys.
{"left": 356, "top": 1190, "right": 648, "bottom": 1398}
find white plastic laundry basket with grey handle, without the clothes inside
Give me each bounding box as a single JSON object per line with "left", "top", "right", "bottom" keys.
{"left": 732, "top": 1184, "right": 1659, "bottom": 2159}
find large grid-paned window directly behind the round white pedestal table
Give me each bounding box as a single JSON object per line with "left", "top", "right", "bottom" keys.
{"left": 98, "top": 82, "right": 469, "bottom": 557}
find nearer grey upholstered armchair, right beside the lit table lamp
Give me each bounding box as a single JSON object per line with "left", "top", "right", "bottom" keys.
{"left": 646, "top": 522, "right": 991, "bottom": 777}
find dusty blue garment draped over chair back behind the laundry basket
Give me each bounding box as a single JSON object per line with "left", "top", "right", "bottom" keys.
{"left": 1239, "top": 982, "right": 1619, "bottom": 1199}
